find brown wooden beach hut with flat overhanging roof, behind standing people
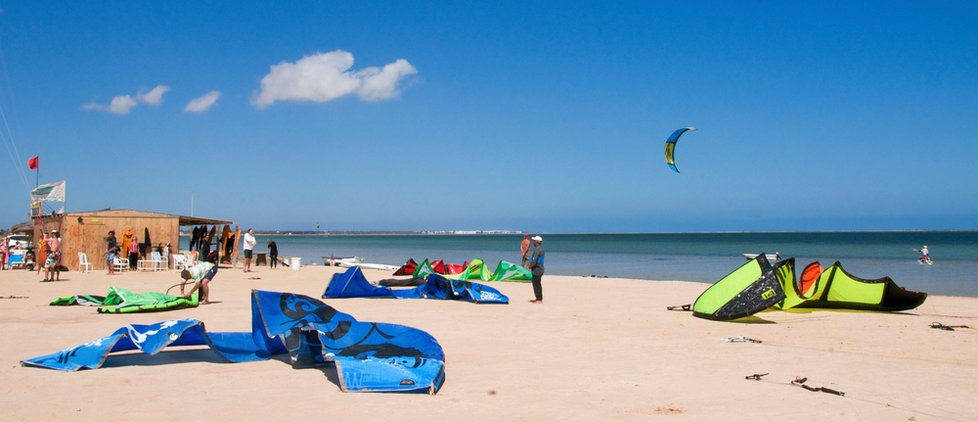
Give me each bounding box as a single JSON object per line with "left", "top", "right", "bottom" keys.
{"left": 34, "top": 209, "right": 235, "bottom": 271}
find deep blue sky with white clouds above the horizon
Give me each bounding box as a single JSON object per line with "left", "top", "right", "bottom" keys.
{"left": 0, "top": 1, "right": 978, "bottom": 232}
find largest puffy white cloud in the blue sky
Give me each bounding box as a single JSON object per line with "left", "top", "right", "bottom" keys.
{"left": 251, "top": 50, "right": 418, "bottom": 108}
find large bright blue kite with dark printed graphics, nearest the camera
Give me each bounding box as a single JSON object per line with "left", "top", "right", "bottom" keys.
{"left": 21, "top": 290, "right": 445, "bottom": 394}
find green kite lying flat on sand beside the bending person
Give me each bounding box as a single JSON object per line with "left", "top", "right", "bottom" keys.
{"left": 51, "top": 287, "right": 198, "bottom": 314}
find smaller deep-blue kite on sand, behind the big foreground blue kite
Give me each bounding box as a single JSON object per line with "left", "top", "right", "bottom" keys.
{"left": 323, "top": 266, "right": 509, "bottom": 303}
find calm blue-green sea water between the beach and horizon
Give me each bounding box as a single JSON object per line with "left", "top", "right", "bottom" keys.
{"left": 181, "top": 231, "right": 978, "bottom": 296}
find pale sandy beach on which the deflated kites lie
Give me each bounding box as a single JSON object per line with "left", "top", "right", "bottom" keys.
{"left": 0, "top": 266, "right": 978, "bottom": 421}
